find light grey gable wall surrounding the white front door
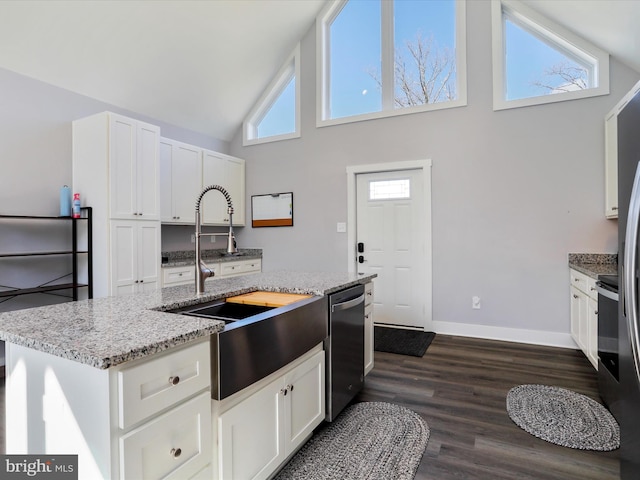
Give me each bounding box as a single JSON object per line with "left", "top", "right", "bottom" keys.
{"left": 231, "top": 1, "right": 640, "bottom": 345}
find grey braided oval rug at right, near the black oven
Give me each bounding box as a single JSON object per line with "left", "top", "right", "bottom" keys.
{"left": 507, "top": 385, "right": 620, "bottom": 451}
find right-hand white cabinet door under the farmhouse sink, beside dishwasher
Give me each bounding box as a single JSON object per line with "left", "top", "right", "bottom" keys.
{"left": 284, "top": 352, "right": 325, "bottom": 455}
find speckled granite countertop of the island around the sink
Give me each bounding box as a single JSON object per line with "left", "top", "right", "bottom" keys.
{"left": 0, "top": 271, "right": 376, "bottom": 369}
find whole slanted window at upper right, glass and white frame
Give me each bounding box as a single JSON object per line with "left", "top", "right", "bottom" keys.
{"left": 492, "top": 0, "right": 609, "bottom": 110}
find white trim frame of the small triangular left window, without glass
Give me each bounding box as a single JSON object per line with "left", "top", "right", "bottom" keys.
{"left": 242, "top": 43, "right": 301, "bottom": 147}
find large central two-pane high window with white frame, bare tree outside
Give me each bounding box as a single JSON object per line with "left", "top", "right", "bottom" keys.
{"left": 317, "top": 0, "right": 466, "bottom": 126}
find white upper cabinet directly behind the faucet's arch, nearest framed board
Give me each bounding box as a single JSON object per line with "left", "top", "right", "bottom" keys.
{"left": 201, "top": 150, "right": 245, "bottom": 225}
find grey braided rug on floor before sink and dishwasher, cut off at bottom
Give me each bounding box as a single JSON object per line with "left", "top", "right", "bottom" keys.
{"left": 275, "top": 402, "right": 430, "bottom": 480}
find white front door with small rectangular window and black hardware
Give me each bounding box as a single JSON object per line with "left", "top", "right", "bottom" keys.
{"left": 356, "top": 169, "right": 432, "bottom": 330}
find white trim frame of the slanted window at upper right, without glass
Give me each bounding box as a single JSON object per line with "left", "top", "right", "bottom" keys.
{"left": 491, "top": 0, "right": 609, "bottom": 111}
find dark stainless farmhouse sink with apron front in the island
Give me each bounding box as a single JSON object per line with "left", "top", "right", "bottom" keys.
{"left": 169, "top": 296, "right": 329, "bottom": 400}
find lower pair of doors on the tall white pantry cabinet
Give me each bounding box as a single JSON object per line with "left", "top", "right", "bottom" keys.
{"left": 110, "top": 220, "right": 160, "bottom": 295}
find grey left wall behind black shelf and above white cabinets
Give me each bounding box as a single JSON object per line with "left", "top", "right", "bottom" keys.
{"left": 0, "top": 69, "right": 229, "bottom": 312}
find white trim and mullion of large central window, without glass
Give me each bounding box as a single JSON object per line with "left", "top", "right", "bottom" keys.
{"left": 316, "top": 0, "right": 467, "bottom": 128}
